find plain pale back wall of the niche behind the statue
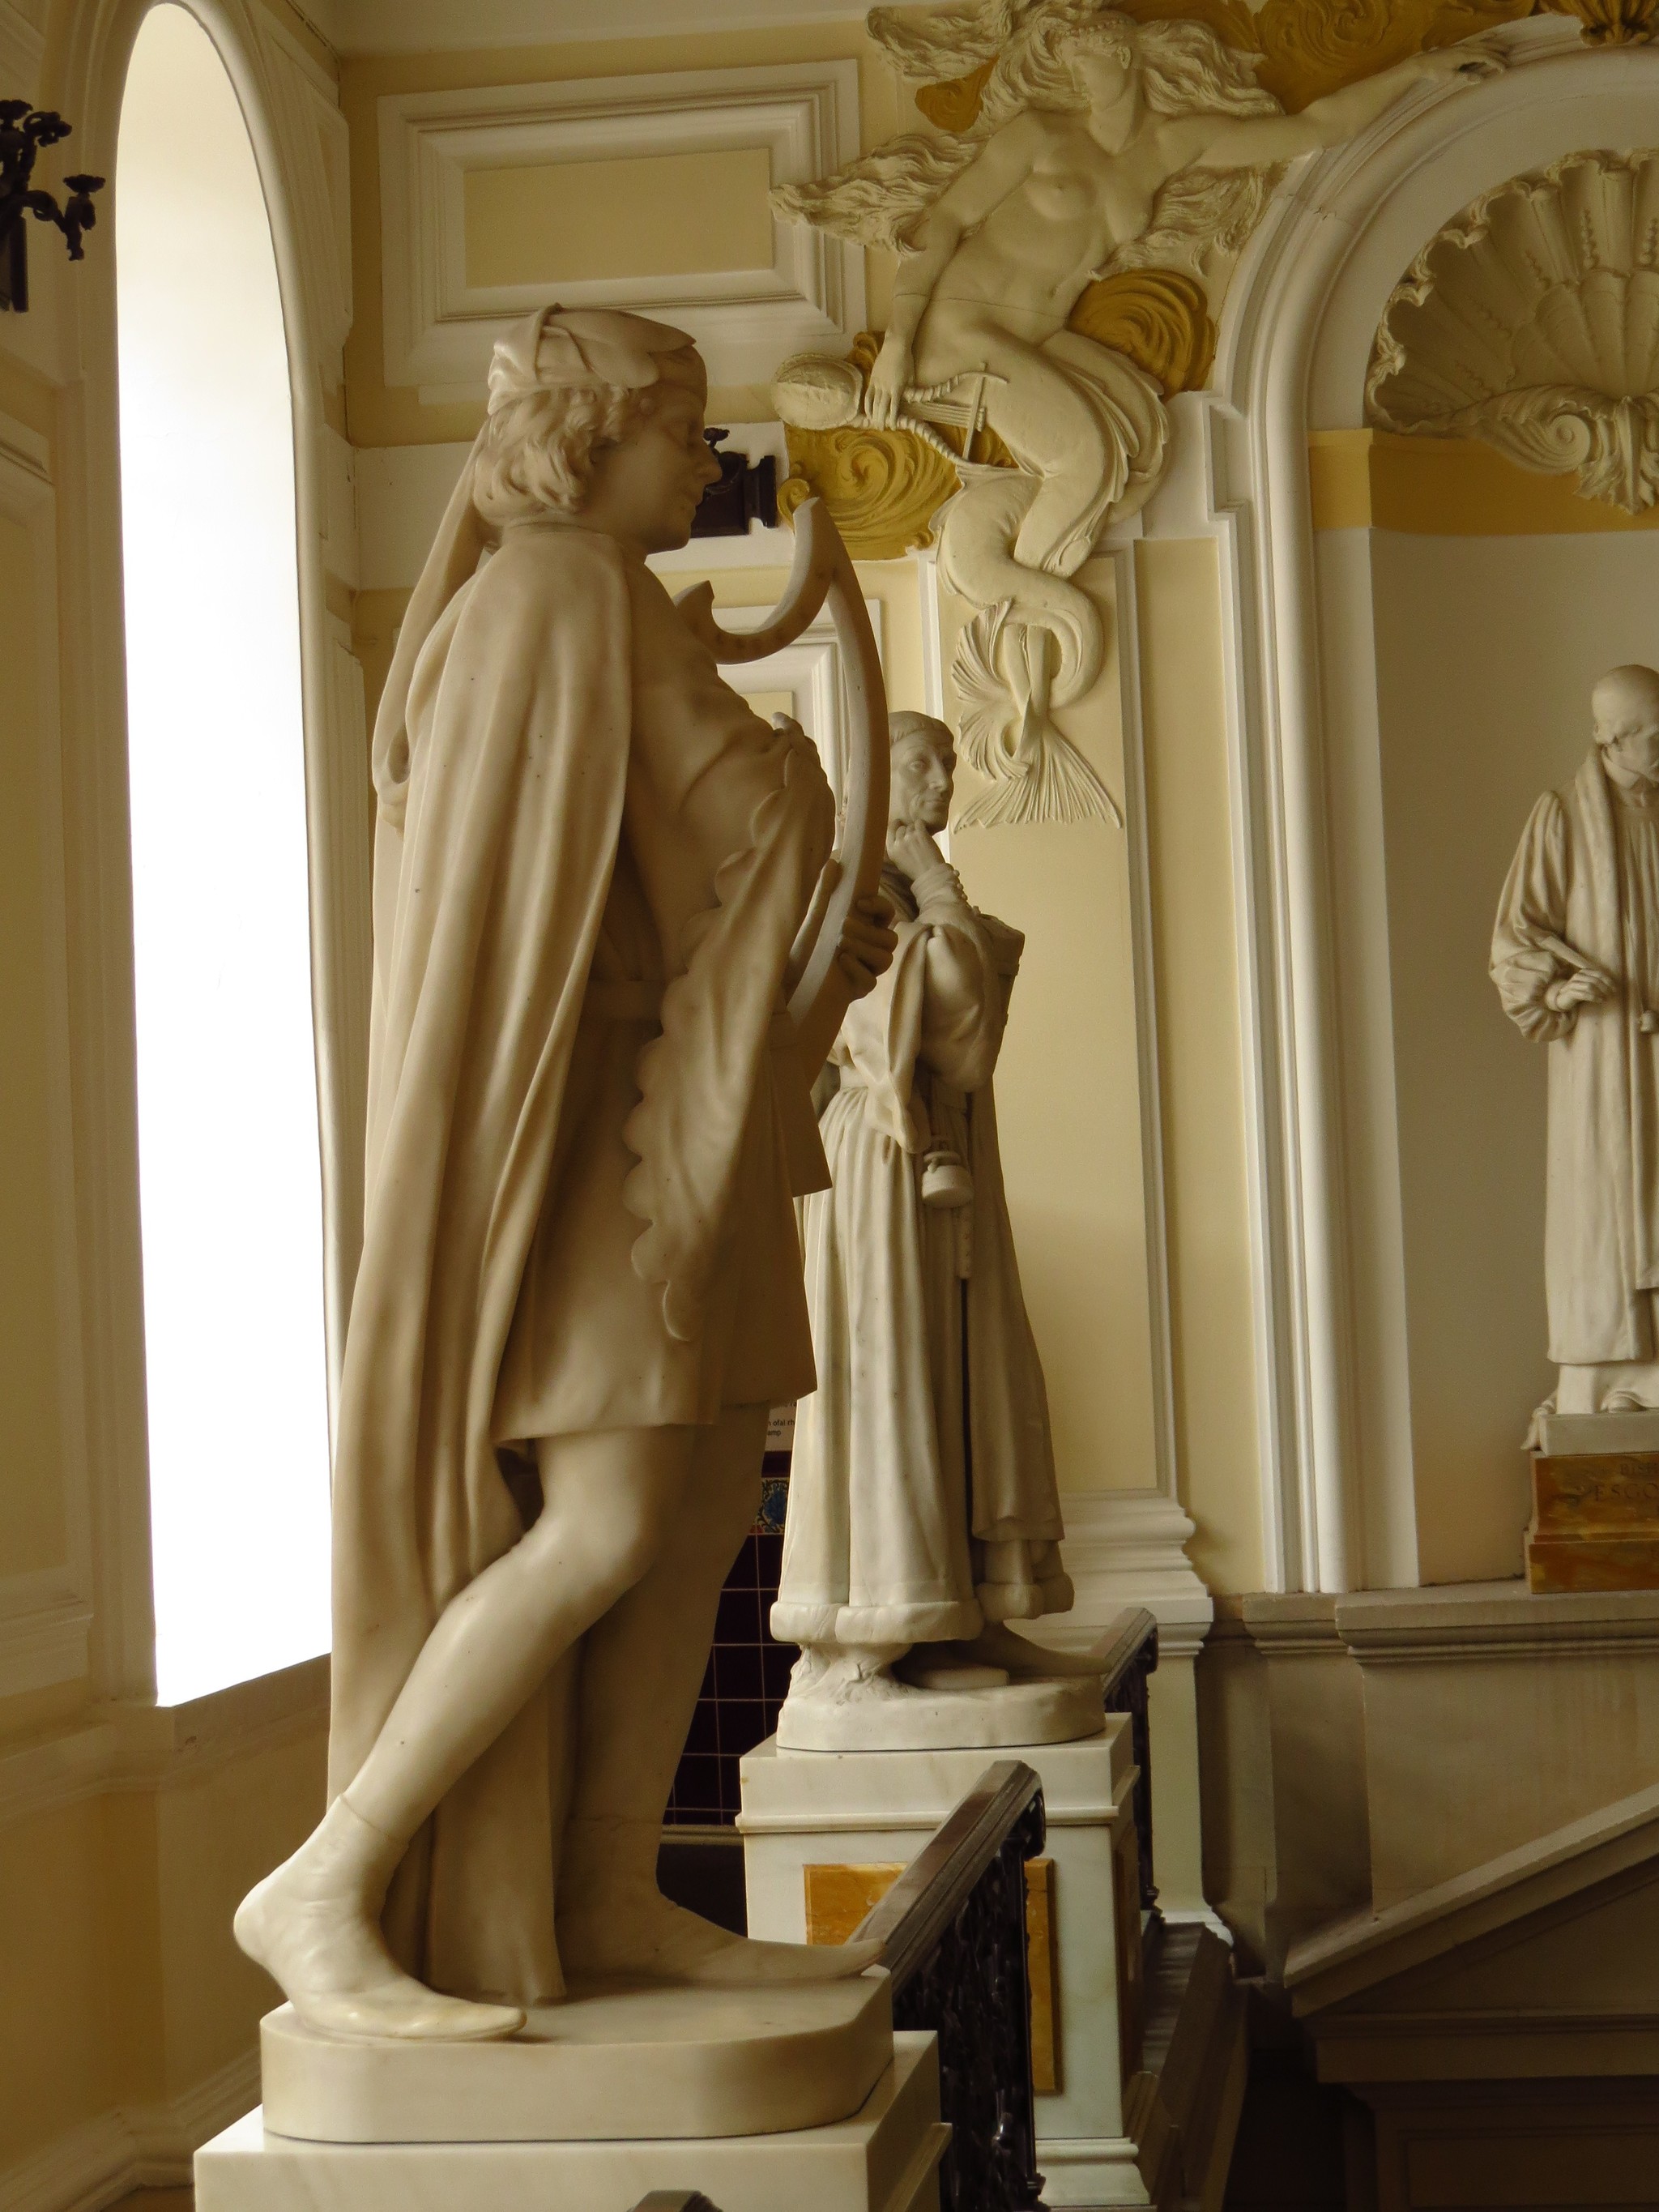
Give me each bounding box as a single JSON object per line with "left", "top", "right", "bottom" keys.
{"left": 1371, "top": 526, "right": 1659, "bottom": 1582}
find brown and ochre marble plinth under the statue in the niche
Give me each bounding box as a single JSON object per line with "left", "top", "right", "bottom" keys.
{"left": 1526, "top": 1413, "right": 1659, "bottom": 1595}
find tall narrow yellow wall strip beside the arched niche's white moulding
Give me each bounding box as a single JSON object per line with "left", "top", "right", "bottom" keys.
{"left": 1135, "top": 540, "right": 1263, "bottom": 1591}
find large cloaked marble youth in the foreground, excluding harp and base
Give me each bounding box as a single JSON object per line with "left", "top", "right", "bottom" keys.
{"left": 237, "top": 310, "right": 893, "bottom": 2037}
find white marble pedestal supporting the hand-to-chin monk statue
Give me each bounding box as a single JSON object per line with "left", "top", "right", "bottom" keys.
{"left": 743, "top": 1715, "right": 1148, "bottom": 2208}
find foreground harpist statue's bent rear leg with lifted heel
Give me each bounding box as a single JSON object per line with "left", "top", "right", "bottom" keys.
{"left": 237, "top": 1429, "right": 702, "bottom": 2042}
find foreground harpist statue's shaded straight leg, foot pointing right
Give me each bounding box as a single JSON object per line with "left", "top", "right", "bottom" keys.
{"left": 557, "top": 1407, "right": 878, "bottom": 1982}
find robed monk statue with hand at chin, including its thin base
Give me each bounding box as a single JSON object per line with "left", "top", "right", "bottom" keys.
{"left": 772, "top": 715, "right": 1099, "bottom": 1749}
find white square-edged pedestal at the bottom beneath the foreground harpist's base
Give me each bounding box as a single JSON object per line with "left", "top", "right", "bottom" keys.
{"left": 194, "top": 2035, "right": 949, "bottom": 2212}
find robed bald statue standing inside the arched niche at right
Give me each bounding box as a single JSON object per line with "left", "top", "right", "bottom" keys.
{"left": 1491, "top": 666, "right": 1659, "bottom": 1413}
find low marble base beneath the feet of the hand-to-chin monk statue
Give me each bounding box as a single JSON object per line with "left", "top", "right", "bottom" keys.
{"left": 776, "top": 1675, "right": 1106, "bottom": 1752}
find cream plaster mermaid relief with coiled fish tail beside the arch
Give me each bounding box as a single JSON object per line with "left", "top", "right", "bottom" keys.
{"left": 772, "top": 0, "right": 1499, "bottom": 823}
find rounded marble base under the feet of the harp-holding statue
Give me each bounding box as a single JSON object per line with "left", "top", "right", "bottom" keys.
{"left": 258, "top": 1966, "right": 893, "bottom": 2143}
